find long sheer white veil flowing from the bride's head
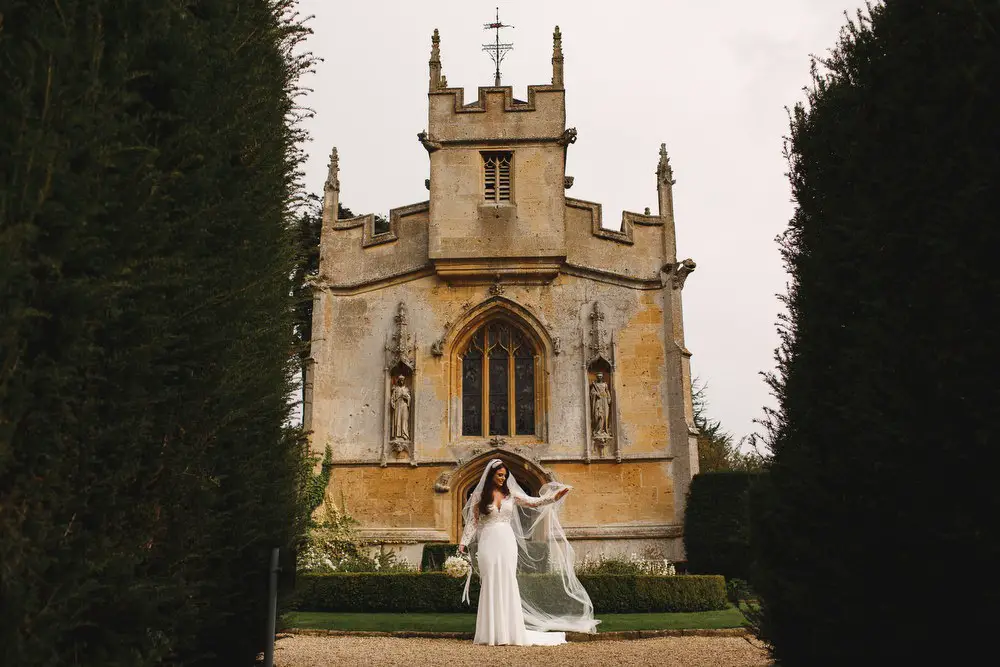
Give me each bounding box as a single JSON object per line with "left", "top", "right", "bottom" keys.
{"left": 462, "top": 459, "right": 600, "bottom": 634}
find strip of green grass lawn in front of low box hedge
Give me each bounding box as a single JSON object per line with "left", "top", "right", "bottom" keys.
{"left": 285, "top": 607, "right": 743, "bottom": 632}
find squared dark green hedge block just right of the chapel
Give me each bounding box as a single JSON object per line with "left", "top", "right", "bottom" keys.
{"left": 684, "top": 470, "right": 761, "bottom": 579}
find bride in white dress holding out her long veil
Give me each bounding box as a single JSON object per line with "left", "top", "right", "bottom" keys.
{"left": 458, "top": 459, "right": 600, "bottom": 646}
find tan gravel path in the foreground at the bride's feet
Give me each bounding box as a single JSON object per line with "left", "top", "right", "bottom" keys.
{"left": 274, "top": 635, "right": 771, "bottom": 667}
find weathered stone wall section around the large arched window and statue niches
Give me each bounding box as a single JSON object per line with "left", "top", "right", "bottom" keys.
{"left": 311, "top": 275, "right": 670, "bottom": 462}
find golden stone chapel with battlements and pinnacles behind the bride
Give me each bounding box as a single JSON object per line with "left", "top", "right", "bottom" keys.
{"left": 303, "top": 27, "right": 698, "bottom": 563}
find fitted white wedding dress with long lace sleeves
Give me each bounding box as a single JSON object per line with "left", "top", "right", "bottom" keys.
{"left": 463, "top": 494, "right": 566, "bottom": 646}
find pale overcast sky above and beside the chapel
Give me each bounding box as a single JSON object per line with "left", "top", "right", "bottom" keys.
{"left": 299, "top": 0, "right": 863, "bottom": 446}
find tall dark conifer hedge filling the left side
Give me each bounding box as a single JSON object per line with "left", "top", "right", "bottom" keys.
{"left": 0, "top": 0, "right": 308, "bottom": 667}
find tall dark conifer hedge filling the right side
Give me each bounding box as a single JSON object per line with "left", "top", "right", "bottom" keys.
{"left": 752, "top": 0, "right": 1000, "bottom": 666}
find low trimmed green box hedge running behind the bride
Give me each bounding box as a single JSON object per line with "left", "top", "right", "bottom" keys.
{"left": 293, "top": 572, "right": 728, "bottom": 614}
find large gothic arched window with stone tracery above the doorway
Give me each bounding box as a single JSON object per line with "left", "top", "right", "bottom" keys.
{"left": 461, "top": 321, "right": 537, "bottom": 437}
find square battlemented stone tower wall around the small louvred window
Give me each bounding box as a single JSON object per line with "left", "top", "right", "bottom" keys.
{"left": 428, "top": 86, "right": 566, "bottom": 260}
